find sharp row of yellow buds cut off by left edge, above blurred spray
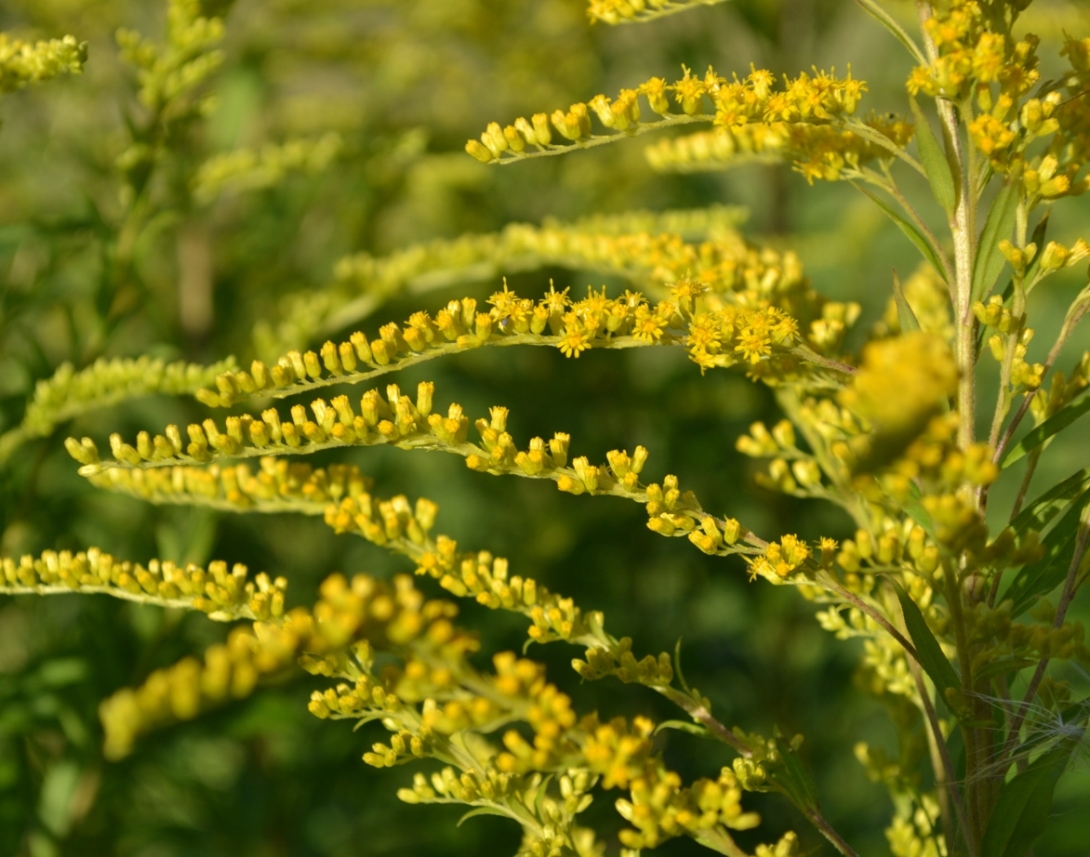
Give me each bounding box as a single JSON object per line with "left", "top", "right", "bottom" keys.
{"left": 0, "top": 547, "right": 288, "bottom": 620}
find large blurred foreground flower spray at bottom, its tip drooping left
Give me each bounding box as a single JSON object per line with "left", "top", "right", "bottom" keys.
{"left": 93, "top": 562, "right": 794, "bottom": 855}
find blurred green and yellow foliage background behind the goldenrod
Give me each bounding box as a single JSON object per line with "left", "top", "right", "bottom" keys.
{"left": 0, "top": 0, "right": 1090, "bottom": 857}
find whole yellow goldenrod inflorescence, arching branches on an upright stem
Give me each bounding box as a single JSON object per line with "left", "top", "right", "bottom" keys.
{"left": 6, "top": 0, "right": 1090, "bottom": 857}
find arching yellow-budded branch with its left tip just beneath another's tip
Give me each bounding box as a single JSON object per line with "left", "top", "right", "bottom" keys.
{"left": 82, "top": 452, "right": 749, "bottom": 756}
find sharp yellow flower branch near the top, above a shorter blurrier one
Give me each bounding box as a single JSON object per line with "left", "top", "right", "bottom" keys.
{"left": 465, "top": 69, "right": 867, "bottom": 164}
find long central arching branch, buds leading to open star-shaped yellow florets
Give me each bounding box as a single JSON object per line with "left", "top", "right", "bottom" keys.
{"left": 197, "top": 278, "right": 810, "bottom": 415}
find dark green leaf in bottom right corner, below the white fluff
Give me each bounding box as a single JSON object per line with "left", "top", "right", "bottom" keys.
{"left": 980, "top": 747, "right": 1071, "bottom": 857}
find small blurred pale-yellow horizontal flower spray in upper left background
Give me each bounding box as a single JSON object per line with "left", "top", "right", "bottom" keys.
{"left": 192, "top": 132, "right": 341, "bottom": 204}
